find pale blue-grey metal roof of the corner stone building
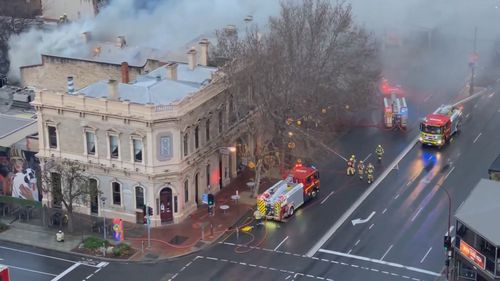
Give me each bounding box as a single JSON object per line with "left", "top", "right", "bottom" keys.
{"left": 79, "top": 63, "right": 216, "bottom": 105}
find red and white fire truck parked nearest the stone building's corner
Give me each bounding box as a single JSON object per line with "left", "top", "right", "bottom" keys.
{"left": 257, "top": 161, "right": 319, "bottom": 221}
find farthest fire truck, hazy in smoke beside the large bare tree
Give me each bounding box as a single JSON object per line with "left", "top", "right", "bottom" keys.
{"left": 379, "top": 78, "right": 408, "bottom": 130}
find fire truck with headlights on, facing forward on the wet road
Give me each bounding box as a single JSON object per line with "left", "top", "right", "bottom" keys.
{"left": 419, "top": 105, "right": 463, "bottom": 148}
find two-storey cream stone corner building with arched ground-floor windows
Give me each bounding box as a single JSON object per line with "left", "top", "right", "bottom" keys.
{"left": 33, "top": 41, "right": 253, "bottom": 223}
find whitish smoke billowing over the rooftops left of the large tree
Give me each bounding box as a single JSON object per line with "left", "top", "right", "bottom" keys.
{"left": 9, "top": 0, "right": 279, "bottom": 80}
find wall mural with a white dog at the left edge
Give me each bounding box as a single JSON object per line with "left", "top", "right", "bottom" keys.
{"left": 0, "top": 149, "right": 41, "bottom": 202}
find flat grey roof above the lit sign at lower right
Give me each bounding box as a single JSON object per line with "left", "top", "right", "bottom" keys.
{"left": 455, "top": 179, "right": 500, "bottom": 246}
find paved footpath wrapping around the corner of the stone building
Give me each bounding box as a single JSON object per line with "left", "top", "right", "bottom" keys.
{"left": 0, "top": 171, "right": 271, "bottom": 261}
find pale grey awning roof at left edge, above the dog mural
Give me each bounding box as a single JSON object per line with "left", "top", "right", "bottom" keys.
{"left": 0, "top": 114, "right": 38, "bottom": 147}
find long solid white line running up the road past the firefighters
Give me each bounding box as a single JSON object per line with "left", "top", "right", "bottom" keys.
{"left": 306, "top": 137, "right": 418, "bottom": 257}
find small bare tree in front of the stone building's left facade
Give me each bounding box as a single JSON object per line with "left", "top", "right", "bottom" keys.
{"left": 42, "top": 159, "right": 100, "bottom": 232}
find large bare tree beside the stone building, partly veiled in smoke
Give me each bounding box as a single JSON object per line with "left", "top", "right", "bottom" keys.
{"left": 212, "top": 0, "right": 380, "bottom": 197}
